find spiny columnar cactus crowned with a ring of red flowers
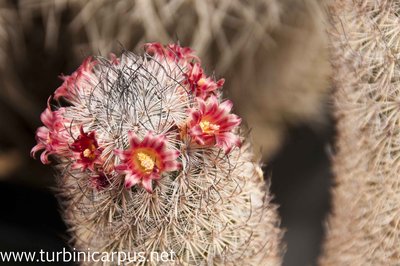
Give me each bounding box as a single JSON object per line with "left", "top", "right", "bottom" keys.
{"left": 32, "top": 43, "right": 281, "bottom": 265}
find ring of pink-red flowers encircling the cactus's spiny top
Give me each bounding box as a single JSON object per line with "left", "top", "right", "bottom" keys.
{"left": 31, "top": 43, "right": 241, "bottom": 192}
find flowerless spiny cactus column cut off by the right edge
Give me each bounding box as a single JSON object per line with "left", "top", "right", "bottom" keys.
{"left": 320, "top": 0, "right": 400, "bottom": 265}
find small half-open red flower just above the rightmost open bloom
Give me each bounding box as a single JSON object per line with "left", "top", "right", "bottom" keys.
{"left": 185, "top": 63, "right": 225, "bottom": 99}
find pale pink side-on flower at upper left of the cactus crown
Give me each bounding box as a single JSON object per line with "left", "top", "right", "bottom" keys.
{"left": 54, "top": 57, "right": 96, "bottom": 100}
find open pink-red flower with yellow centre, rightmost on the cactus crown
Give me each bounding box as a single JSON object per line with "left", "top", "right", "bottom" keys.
{"left": 188, "top": 96, "right": 241, "bottom": 154}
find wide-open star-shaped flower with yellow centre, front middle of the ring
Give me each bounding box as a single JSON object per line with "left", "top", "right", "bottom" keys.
{"left": 115, "top": 132, "right": 181, "bottom": 193}
